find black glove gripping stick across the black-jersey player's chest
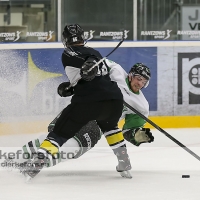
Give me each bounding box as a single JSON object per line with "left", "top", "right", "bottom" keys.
{"left": 80, "top": 57, "right": 98, "bottom": 81}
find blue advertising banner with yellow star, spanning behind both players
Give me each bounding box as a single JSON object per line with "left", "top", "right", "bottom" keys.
{"left": 0, "top": 47, "right": 157, "bottom": 117}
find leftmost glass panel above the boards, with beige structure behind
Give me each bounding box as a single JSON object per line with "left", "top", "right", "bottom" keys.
{"left": 0, "top": 0, "right": 57, "bottom": 42}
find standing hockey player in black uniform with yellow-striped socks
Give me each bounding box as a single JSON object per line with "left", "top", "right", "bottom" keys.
{"left": 23, "top": 24, "right": 131, "bottom": 178}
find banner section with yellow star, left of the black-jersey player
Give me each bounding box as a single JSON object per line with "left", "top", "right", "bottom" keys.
{"left": 0, "top": 49, "right": 67, "bottom": 120}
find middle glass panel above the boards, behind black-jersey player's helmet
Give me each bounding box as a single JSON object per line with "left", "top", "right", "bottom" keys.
{"left": 62, "top": 0, "right": 133, "bottom": 41}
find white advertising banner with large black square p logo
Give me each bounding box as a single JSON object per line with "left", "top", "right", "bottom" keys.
{"left": 157, "top": 46, "right": 200, "bottom": 116}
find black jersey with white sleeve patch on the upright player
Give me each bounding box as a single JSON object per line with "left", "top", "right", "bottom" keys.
{"left": 62, "top": 46, "right": 123, "bottom": 102}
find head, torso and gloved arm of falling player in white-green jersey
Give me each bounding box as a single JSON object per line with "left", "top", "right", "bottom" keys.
{"left": 107, "top": 60, "right": 151, "bottom": 143}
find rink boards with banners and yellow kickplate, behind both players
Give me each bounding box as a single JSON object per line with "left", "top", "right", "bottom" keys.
{"left": 0, "top": 41, "right": 200, "bottom": 134}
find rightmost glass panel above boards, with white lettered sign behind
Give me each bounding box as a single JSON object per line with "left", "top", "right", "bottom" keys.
{"left": 137, "top": 0, "right": 200, "bottom": 40}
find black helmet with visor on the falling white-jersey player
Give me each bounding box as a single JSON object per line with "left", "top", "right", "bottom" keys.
{"left": 129, "top": 63, "right": 151, "bottom": 88}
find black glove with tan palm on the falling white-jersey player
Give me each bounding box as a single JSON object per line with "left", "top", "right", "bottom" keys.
{"left": 124, "top": 128, "right": 154, "bottom": 146}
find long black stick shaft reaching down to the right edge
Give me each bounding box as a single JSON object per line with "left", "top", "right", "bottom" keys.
{"left": 124, "top": 101, "right": 200, "bottom": 161}
